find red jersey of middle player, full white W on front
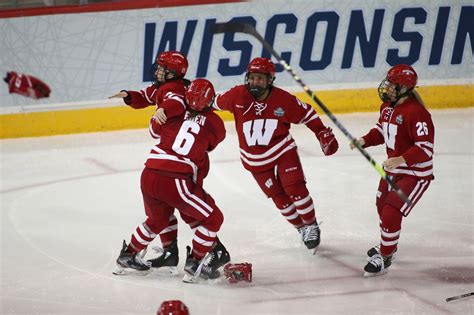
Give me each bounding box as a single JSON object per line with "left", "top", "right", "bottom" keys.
{"left": 214, "top": 85, "right": 324, "bottom": 172}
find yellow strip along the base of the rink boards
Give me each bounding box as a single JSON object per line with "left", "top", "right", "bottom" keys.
{"left": 0, "top": 85, "right": 474, "bottom": 139}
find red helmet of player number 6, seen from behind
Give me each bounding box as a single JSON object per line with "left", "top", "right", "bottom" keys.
{"left": 184, "top": 79, "right": 216, "bottom": 112}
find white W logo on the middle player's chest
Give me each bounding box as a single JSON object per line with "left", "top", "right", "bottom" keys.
{"left": 243, "top": 119, "right": 278, "bottom": 147}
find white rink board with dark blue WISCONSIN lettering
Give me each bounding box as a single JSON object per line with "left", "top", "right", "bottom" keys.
{"left": 0, "top": 0, "right": 474, "bottom": 107}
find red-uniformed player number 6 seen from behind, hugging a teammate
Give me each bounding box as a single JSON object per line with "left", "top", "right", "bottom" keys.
{"left": 114, "top": 79, "right": 230, "bottom": 282}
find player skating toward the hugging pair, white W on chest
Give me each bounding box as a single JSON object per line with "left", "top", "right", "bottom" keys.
{"left": 214, "top": 58, "right": 338, "bottom": 253}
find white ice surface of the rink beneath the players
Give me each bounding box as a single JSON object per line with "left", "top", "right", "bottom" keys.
{"left": 0, "top": 108, "right": 474, "bottom": 315}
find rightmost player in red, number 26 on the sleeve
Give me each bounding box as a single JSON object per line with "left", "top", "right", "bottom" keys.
{"left": 351, "top": 64, "right": 435, "bottom": 276}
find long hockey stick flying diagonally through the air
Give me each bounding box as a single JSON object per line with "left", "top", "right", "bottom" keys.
{"left": 211, "top": 22, "right": 411, "bottom": 206}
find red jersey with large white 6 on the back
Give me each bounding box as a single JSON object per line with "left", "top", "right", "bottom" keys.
{"left": 145, "top": 111, "right": 225, "bottom": 182}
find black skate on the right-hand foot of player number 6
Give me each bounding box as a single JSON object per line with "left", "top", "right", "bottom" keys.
{"left": 183, "top": 246, "right": 221, "bottom": 283}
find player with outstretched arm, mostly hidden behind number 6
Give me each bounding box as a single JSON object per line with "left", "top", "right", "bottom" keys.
{"left": 110, "top": 51, "right": 200, "bottom": 268}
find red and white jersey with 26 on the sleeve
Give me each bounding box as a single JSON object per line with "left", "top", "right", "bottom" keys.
{"left": 363, "top": 98, "right": 435, "bottom": 179}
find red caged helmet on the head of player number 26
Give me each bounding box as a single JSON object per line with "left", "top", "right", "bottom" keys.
{"left": 378, "top": 64, "right": 418, "bottom": 104}
